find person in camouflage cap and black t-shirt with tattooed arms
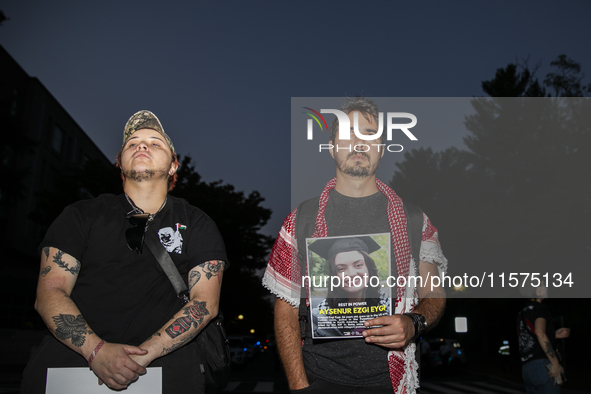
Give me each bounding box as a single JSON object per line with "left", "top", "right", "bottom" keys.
{"left": 21, "top": 111, "right": 227, "bottom": 393}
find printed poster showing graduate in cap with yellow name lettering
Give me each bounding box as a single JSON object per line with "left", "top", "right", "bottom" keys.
{"left": 304, "top": 233, "right": 392, "bottom": 339}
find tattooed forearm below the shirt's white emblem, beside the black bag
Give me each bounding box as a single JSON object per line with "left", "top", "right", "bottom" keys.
{"left": 132, "top": 260, "right": 224, "bottom": 366}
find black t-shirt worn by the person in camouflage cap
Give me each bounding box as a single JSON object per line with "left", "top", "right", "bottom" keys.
{"left": 39, "top": 194, "right": 227, "bottom": 345}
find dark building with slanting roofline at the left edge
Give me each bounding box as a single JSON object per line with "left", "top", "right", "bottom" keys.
{"left": 0, "top": 46, "right": 114, "bottom": 328}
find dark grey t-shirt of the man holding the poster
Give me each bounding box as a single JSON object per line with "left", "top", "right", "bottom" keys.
{"left": 302, "top": 189, "right": 396, "bottom": 386}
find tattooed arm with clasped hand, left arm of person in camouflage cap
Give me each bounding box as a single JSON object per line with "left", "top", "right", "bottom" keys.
{"left": 35, "top": 247, "right": 146, "bottom": 389}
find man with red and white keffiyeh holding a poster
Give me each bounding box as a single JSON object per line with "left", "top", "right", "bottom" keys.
{"left": 263, "top": 97, "right": 447, "bottom": 393}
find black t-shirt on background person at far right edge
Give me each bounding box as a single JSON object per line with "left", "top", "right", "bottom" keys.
{"left": 517, "top": 301, "right": 556, "bottom": 364}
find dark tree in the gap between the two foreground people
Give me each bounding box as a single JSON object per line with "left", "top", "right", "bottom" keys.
{"left": 171, "top": 156, "right": 274, "bottom": 334}
